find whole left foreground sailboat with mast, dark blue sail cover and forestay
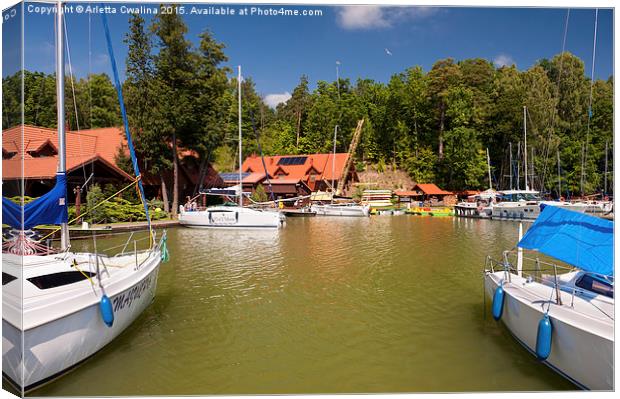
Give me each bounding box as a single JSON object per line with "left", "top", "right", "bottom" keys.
{"left": 2, "top": 2, "right": 166, "bottom": 395}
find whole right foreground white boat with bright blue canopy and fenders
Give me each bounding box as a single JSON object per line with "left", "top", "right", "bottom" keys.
{"left": 484, "top": 206, "right": 615, "bottom": 390}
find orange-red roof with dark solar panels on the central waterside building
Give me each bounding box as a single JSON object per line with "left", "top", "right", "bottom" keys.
{"left": 242, "top": 153, "right": 349, "bottom": 182}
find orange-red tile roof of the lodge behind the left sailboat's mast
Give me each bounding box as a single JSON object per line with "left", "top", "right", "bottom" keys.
{"left": 2, "top": 125, "right": 133, "bottom": 179}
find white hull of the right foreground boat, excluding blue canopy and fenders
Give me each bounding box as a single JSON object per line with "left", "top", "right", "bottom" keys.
{"left": 485, "top": 271, "right": 614, "bottom": 390}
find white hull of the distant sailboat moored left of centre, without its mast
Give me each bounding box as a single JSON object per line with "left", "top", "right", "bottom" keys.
{"left": 179, "top": 206, "right": 285, "bottom": 229}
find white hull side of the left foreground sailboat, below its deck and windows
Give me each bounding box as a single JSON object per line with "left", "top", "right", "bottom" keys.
{"left": 2, "top": 250, "right": 161, "bottom": 391}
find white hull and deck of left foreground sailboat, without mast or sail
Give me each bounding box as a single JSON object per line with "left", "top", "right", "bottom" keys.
{"left": 2, "top": 248, "right": 161, "bottom": 391}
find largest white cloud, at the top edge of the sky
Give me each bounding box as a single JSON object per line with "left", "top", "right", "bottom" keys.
{"left": 337, "top": 6, "right": 439, "bottom": 30}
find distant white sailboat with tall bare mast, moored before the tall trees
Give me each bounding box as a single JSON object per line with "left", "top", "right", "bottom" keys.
{"left": 179, "top": 66, "right": 285, "bottom": 229}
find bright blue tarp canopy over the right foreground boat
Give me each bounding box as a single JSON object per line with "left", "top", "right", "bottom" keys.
{"left": 517, "top": 206, "right": 614, "bottom": 276}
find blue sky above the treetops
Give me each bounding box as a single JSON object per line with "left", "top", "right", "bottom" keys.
{"left": 3, "top": 3, "right": 613, "bottom": 108}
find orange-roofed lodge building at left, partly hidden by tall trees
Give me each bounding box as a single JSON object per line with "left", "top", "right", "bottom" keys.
{"left": 2, "top": 125, "right": 224, "bottom": 203}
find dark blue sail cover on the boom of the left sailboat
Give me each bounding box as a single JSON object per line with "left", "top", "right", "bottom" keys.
{"left": 2, "top": 173, "right": 69, "bottom": 230}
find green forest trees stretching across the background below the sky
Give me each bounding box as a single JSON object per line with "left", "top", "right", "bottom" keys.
{"left": 2, "top": 9, "right": 613, "bottom": 198}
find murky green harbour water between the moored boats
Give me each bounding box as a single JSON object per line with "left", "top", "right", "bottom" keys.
{"left": 27, "top": 216, "right": 575, "bottom": 396}
